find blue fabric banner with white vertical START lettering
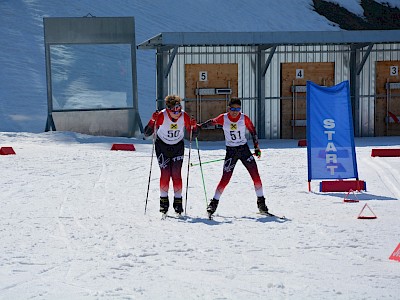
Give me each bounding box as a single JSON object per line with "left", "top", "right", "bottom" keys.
{"left": 307, "top": 81, "right": 358, "bottom": 181}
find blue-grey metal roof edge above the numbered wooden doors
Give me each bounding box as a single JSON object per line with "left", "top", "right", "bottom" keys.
{"left": 137, "top": 30, "right": 400, "bottom": 49}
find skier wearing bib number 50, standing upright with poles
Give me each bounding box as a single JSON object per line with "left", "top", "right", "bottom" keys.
{"left": 144, "top": 95, "right": 198, "bottom": 214}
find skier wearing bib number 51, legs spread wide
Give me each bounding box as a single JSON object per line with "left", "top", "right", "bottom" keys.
{"left": 199, "top": 98, "right": 268, "bottom": 217}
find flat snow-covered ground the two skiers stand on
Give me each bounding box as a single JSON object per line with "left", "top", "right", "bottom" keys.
{"left": 0, "top": 132, "right": 400, "bottom": 299}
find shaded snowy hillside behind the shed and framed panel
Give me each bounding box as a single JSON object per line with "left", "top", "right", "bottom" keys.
{"left": 0, "top": 0, "right": 338, "bottom": 132}
